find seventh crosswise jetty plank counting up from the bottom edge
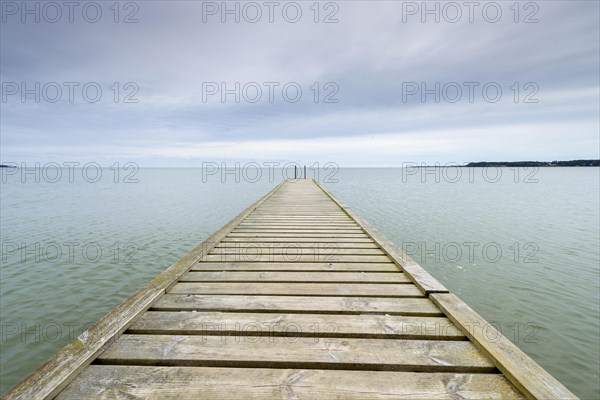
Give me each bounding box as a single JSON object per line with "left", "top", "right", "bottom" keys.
{"left": 192, "top": 262, "right": 402, "bottom": 273}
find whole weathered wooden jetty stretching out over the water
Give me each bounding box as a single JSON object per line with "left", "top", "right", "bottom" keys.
{"left": 6, "top": 180, "right": 576, "bottom": 400}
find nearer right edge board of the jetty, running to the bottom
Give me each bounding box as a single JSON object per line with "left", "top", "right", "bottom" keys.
{"left": 430, "top": 293, "right": 577, "bottom": 399}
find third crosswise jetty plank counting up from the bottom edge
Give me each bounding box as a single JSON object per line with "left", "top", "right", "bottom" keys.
{"left": 127, "top": 311, "right": 466, "bottom": 340}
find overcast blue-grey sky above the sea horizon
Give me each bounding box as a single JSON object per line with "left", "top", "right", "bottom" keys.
{"left": 0, "top": 1, "right": 600, "bottom": 166}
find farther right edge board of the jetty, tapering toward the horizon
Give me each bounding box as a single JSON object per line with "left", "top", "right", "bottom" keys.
{"left": 315, "top": 182, "right": 448, "bottom": 294}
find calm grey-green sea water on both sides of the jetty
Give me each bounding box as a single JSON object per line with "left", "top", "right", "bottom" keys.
{"left": 0, "top": 168, "right": 600, "bottom": 399}
